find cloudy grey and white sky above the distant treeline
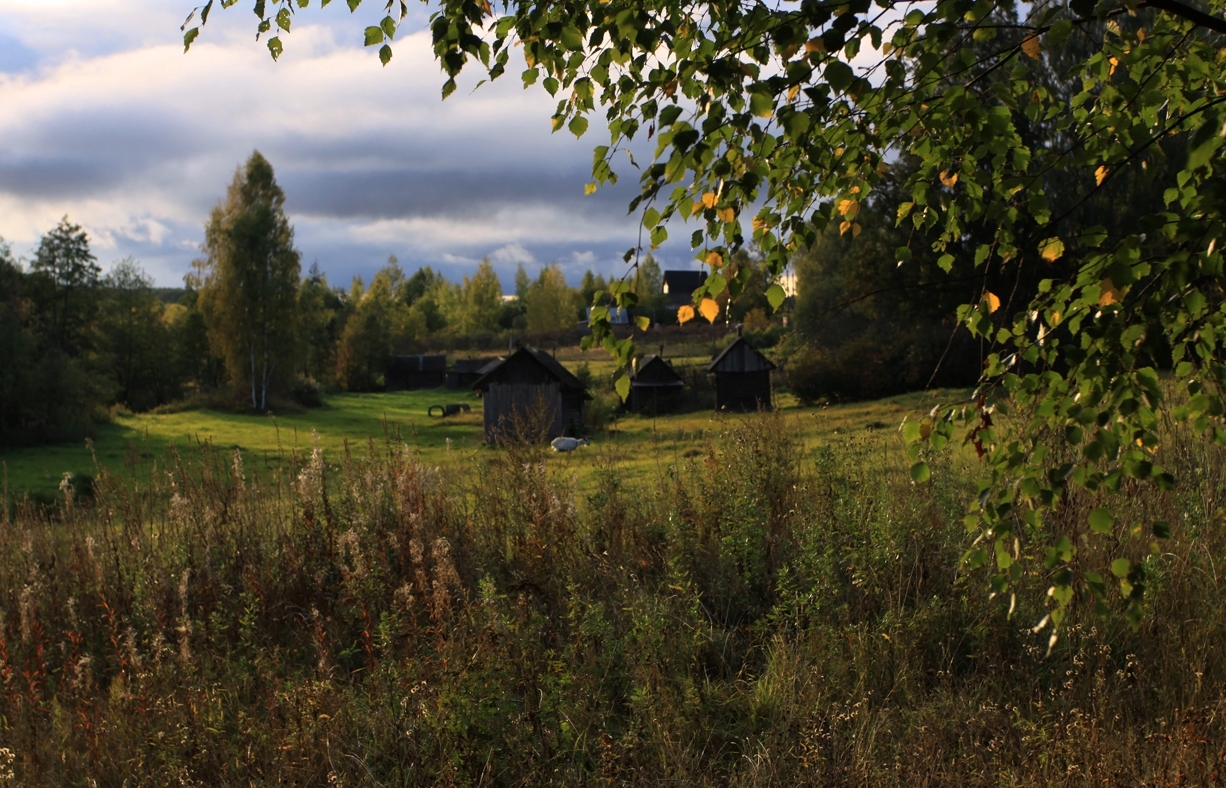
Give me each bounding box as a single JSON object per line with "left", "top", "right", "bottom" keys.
{"left": 0, "top": 0, "right": 690, "bottom": 289}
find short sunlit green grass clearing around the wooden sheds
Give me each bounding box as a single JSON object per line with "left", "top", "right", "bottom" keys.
{"left": 0, "top": 382, "right": 964, "bottom": 500}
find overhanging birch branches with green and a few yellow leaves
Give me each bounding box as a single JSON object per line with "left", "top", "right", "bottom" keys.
{"left": 185, "top": 0, "right": 1226, "bottom": 626}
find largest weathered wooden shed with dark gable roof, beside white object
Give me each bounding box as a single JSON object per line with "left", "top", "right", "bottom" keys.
{"left": 472, "top": 348, "right": 590, "bottom": 444}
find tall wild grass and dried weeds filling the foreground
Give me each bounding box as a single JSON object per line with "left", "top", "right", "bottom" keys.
{"left": 0, "top": 415, "right": 1226, "bottom": 786}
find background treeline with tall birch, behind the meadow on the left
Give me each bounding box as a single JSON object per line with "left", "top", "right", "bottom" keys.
{"left": 0, "top": 153, "right": 701, "bottom": 445}
